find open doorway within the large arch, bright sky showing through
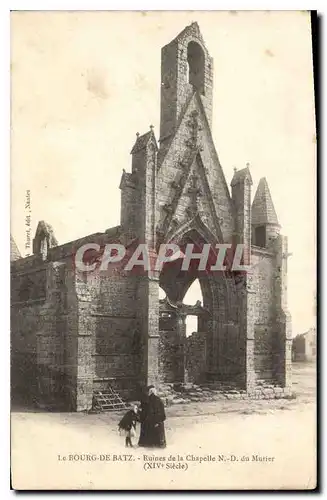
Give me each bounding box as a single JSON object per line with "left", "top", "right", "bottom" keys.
{"left": 159, "top": 247, "right": 211, "bottom": 383}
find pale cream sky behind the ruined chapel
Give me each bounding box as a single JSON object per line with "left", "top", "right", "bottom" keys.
{"left": 11, "top": 11, "right": 316, "bottom": 335}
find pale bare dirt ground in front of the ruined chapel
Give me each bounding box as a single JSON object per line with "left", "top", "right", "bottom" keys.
{"left": 11, "top": 363, "right": 316, "bottom": 490}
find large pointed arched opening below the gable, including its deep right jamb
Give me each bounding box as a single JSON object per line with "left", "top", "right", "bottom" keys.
{"left": 159, "top": 228, "right": 244, "bottom": 383}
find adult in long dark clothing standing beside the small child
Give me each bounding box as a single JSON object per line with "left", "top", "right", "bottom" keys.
{"left": 145, "top": 385, "right": 166, "bottom": 448}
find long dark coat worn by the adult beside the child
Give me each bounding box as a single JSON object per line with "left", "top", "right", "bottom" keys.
{"left": 139, "top": 394, "right": 166, "bottom": 448}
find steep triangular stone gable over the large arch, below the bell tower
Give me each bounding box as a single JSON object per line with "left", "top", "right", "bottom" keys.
{"left": 157, "top": 92, "right": 233, "bottom": 246}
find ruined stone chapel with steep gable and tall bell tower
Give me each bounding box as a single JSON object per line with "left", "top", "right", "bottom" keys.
{"left": 11, "top": 23, "right": 292, "bottom": 410}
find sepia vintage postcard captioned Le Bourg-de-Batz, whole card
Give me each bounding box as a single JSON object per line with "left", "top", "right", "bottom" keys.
{"left": 11, "top": 11, "right": 317, "bottom": 490}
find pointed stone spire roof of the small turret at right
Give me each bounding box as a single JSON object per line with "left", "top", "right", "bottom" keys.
{"left": 252, "top": 177, "right": 278, "bottom": 225}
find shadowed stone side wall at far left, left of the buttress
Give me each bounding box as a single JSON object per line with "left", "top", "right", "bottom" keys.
{"left": 11, "top": 257, "right": 75, "bottom": 406}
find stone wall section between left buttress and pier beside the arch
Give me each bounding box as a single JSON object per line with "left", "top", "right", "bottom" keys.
{"left": 91, "top": 275, "right": 142, "bottom": 395}
